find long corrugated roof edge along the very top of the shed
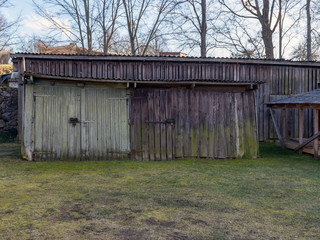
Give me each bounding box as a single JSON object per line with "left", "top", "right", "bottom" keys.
{"left": 10, "top": 53, "right": 320, "bottom": 67}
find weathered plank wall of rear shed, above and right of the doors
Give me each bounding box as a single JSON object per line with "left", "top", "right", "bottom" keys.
{"left": 13, "top": 54, "right": 320, "bottom": 141}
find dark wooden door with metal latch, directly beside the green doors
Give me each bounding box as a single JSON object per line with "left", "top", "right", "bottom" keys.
{"left": 130, "top": 89, "right": 175, "bottom": 161}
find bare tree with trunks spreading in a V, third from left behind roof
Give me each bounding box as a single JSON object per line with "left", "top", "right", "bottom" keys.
{"left": 122, "top": 0, "right": 174, "bottom": 55}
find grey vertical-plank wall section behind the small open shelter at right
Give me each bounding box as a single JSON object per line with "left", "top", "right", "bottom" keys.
{"left": 256, "top": 64, "right": 320, "bottom": 141}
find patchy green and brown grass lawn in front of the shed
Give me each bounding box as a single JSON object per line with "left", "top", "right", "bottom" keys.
{"left": 0, "top": 143, "right": 320, "bottom": 240}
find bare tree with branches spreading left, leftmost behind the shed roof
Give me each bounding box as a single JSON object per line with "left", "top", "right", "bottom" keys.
{"left": 33, "top": 0, "right": 96, "bottom": 54}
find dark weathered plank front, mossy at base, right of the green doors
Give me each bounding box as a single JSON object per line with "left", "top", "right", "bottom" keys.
{"left": 130, "top": 88, "right": 258, "bottom": 160}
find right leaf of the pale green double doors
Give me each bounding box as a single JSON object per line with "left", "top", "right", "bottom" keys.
{"left": 81, "top": 87, "right": 130, "bottom": 160}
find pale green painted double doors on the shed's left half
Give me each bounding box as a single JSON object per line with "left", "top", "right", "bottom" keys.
{"left": 23, "top": 82, "right": 130, "bottom": 160}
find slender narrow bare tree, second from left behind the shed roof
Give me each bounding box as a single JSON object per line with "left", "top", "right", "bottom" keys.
{"left": 96, "top": 0, "right": 121, "bottom": 54}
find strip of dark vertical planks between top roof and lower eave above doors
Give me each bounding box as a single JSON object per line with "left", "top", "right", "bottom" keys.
{"left": 21, "top": 59, "right": 269, "bottom": 83}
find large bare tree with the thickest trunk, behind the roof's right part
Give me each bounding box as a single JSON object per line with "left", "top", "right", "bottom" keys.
{"left": 219, "top": 0, "right": 281, "bottom": 59}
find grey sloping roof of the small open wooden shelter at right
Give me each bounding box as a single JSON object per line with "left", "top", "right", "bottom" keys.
{"left": 265, "top": 89, "right": 320, "bottom": 105}
